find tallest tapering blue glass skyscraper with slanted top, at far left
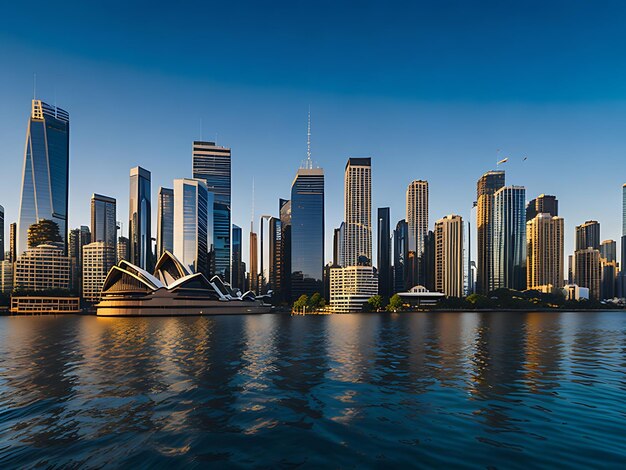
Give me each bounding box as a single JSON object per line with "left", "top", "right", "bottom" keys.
{"left": 17, "top": 100, "right": 70, "bottom": 256}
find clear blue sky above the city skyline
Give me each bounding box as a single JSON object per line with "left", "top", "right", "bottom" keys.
{"left": 0, "top": 0, "right": 626, "bottom": 261}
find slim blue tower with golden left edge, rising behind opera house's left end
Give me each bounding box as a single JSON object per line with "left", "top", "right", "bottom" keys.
{"left": 128, "top": 166, "right": 153, "bottom": 272}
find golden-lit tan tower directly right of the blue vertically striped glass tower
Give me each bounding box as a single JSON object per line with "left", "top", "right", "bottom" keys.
{"left": 526, "top": 213, "right": 565, "bottom": 289}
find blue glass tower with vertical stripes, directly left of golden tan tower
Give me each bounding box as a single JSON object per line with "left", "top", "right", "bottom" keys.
{"left": 493, "top": 186, "right": 526, "bottom": 290}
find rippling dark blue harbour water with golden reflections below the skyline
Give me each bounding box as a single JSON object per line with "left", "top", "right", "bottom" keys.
{"left": 0, "top": 312, "right": 626, "bottom": 468}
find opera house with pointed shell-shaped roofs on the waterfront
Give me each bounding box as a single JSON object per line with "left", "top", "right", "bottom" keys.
{"left": 96, "top": 252, "right": 272, "bottom": 316}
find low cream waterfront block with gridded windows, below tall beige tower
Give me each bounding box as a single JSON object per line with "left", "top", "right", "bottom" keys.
{"left": 330, "top": 266, "right": 378, "bottom": 313}
